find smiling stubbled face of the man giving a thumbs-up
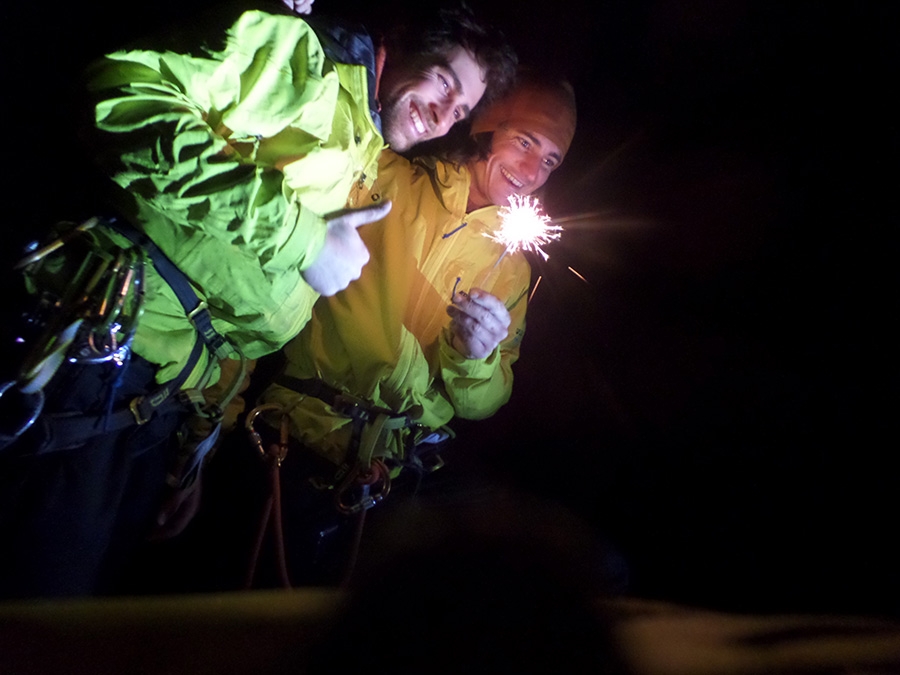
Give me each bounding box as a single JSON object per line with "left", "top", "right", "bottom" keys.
{"left": 379, "top": 47, "right": 486, "bottom": 152}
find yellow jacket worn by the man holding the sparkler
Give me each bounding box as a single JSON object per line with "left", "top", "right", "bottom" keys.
{"left": 264, "top": 151, "right": 531, "bottom": 464}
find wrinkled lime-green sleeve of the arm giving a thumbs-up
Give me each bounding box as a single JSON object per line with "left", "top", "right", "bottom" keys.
{"left": 88, "top": 12, "right": 337, "bottom": 270}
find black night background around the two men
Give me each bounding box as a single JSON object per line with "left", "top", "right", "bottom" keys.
{"left": 2, "top": 0, "right": 900, "bottom": 616}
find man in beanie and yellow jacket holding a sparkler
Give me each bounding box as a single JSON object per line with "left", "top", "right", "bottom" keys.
{"left": 253, "top": 71, "right": 576, "bottom": 584}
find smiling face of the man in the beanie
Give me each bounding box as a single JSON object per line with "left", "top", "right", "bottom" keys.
{"left": 468, "top": 126, "right": 563, "bottom": 210}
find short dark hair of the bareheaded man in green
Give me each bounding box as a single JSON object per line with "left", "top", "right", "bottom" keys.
{"left": 382, "top": 2, "right": 518, "bottom": 108}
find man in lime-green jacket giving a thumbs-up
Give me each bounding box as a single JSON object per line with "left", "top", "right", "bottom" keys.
{"left": 0, "top": 3, "right": 514, "bottom": 597}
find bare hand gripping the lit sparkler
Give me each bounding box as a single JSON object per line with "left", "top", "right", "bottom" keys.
{"left": 447, "top": 288, "right": 510, "bottom": 359}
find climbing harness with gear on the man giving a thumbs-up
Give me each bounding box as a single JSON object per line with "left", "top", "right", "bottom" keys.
{"left": 0, "top": 218, "right": 244, "bottom": 476}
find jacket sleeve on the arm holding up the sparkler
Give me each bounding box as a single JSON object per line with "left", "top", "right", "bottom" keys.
{"left": 440, "top": 265, "right": 529, "bottom": 420}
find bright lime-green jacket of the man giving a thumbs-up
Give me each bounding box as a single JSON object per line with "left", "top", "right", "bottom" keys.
{"left": 82, "top": 11, "right": 384, "bottom": 385}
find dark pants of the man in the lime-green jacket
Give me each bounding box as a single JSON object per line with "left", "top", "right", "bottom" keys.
{"left": 0, "top": 357, "right": 183, "bottom": 598}
